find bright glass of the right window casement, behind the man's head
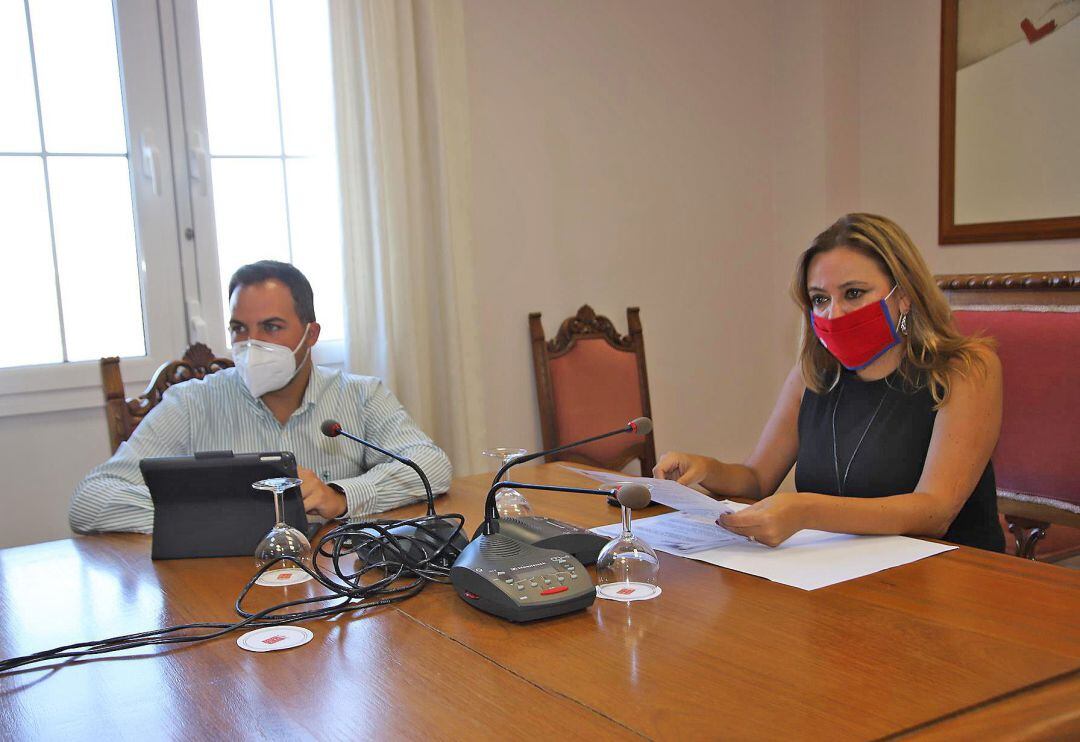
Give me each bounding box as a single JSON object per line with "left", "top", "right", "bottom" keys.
{"left": 198, "top": 0, "right": 343, "bottom": 347}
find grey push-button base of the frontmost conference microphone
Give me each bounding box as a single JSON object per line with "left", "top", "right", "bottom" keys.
{"left": 450, "top": 534, "right": 596, "bottom": 622}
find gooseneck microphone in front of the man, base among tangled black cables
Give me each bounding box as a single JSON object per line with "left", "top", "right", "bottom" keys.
{"left": 319, "top": 420, "right": 469, "bottom": 579}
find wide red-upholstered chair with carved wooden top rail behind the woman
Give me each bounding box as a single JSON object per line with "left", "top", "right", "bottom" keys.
{"left": 936, "top": 271, "right": 1080, "bottom": 562}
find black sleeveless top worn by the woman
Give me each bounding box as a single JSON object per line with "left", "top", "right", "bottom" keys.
{"left": 795, "top": 370, "right": 1005, "bottom": 552}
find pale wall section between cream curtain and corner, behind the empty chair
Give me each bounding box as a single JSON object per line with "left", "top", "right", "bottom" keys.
{"left": 465, "top": 0, "right": 791, "bottom": 475}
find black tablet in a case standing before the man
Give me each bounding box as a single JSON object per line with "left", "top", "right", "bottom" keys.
{"left": 139, "top": 450, "right": 318, "bottom": 559}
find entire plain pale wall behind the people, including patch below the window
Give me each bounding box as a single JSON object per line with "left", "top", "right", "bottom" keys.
{"left": 0, "top": 0, "right": 1080, "bottom": 547}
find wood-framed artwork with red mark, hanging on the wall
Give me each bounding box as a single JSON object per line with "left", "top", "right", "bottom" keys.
{"left": 937, "top": 0, "right": 1080, "bottom": 244}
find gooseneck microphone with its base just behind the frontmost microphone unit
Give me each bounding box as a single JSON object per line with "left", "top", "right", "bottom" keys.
{"left": 473, "top": 417, "right": 652, "bottom": 565}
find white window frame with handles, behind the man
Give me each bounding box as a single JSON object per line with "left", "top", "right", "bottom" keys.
{"left": 0, "top": 0, "right": 346, "bottom": 417}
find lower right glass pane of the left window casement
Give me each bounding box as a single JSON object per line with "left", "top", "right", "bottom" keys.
{"left": 48, "top": 157, "right": 146, "bottom": 361}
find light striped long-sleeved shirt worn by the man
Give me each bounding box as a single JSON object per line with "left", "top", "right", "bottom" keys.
{"left": 68, "top": 366, "right": 450, "bottom": 534}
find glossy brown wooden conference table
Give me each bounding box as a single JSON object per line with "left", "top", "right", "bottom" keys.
{"left": 0, "top": 464, "right": 1080, "bottom": 741}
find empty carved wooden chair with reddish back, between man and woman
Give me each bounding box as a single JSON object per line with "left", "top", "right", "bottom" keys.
{"left": 529, "top": 305, "right": 657, "bottom": 476}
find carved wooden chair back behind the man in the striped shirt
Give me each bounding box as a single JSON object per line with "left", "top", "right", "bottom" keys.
{"left": 102, "top": 342, "right": 232, "bottom": 453}
